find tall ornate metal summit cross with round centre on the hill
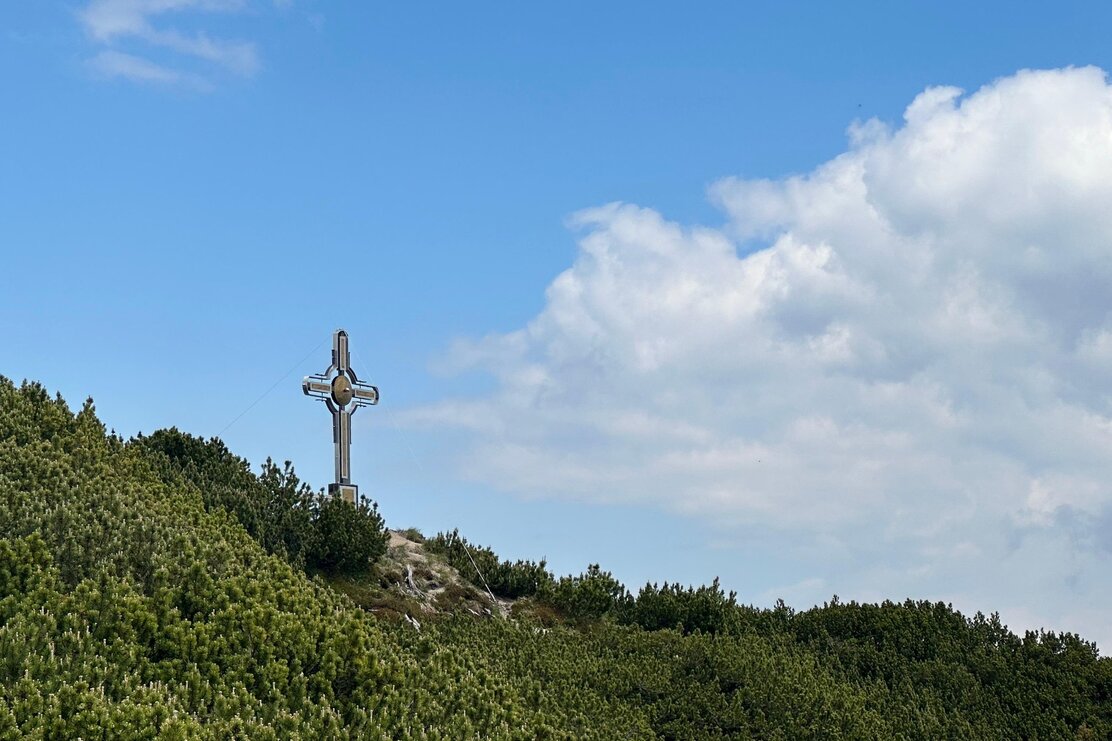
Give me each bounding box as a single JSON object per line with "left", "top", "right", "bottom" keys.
{"left": 301, "top": 329, "right": 378, "bottom": 503}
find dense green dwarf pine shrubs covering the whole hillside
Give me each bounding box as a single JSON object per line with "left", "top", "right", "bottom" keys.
{"left": 0, "top": 378, "right": 1112, "bottom": 739}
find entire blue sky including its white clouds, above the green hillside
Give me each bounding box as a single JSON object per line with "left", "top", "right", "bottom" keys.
{"left": 0, "top": 0, "right": 1112, "bottom": 645}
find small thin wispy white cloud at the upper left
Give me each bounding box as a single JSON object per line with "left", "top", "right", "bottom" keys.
{"left": 79, "top": 0, "right": 260, "bottom": 86}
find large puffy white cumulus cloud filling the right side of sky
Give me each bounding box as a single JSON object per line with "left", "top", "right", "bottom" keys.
{"left": 409, "top": 68, "right": 1112, "bottom": 648}
